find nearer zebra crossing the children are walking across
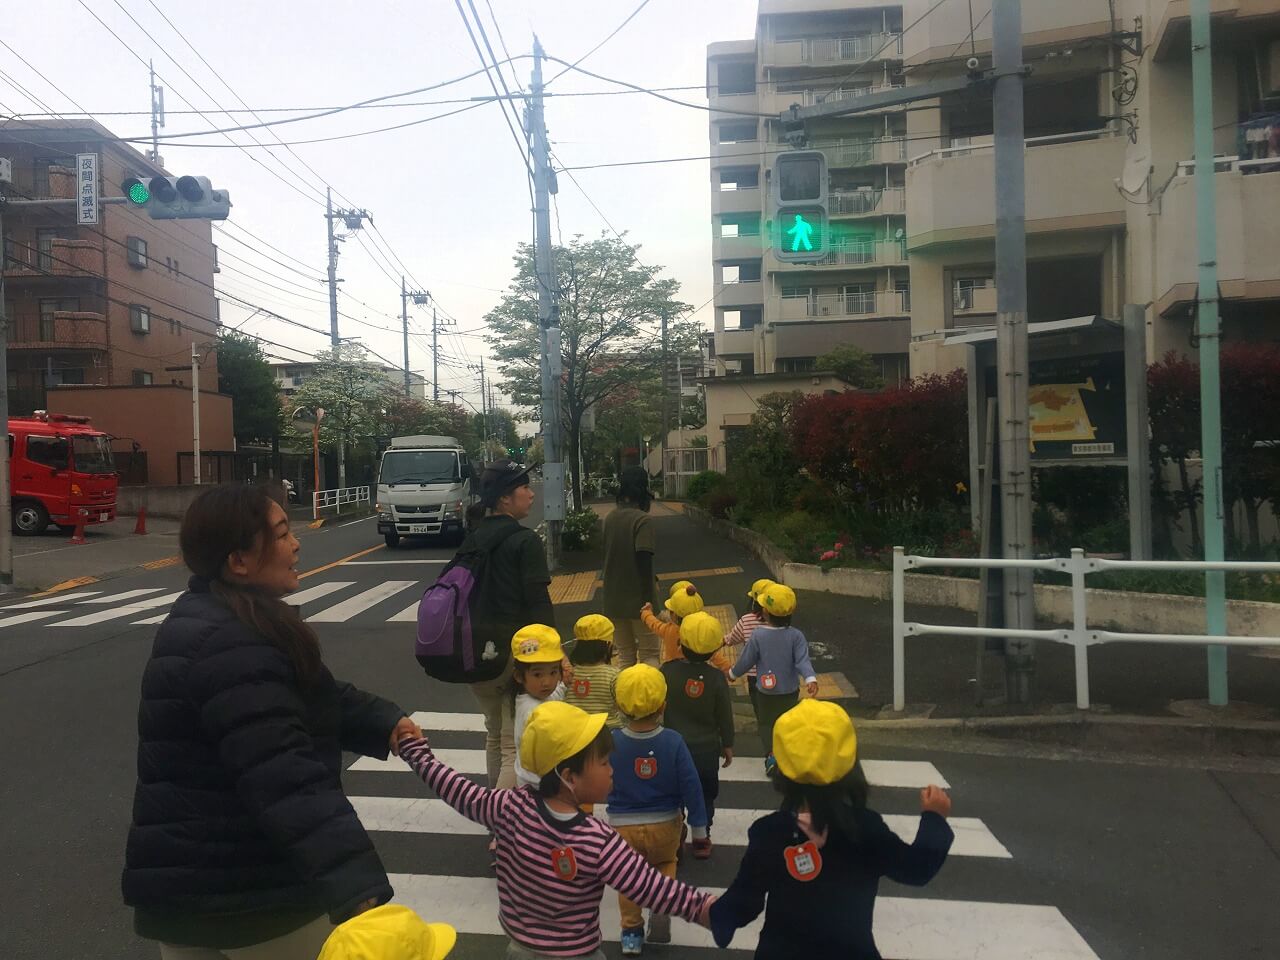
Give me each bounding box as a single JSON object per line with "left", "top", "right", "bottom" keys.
{"left": 346, "top": 712, "right": 1098, "bottom": 960}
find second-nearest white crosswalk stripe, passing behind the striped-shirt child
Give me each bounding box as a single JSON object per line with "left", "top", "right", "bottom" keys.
{"left": 348, "top": 796, "right": 1012, "bottom": 860}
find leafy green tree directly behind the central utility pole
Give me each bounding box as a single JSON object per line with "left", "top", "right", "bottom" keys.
{"left": 485, "top": 237, "right": 701, "bottom": 508}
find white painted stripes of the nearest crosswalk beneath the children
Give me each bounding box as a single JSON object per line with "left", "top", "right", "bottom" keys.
{"left": 348, "top": 710, "right": 1098, "bottom": 960}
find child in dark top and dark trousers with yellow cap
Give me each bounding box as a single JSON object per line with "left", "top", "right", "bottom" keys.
{"left": 662, "top": 611, "right": 733, "bottom": 860}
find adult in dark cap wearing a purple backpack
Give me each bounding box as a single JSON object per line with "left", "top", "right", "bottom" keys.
{"left": 417, "top": 460, "right": 556, "bottom": 790}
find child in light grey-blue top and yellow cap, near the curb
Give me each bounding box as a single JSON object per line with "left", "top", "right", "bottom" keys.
{"left": 728, "top": 584, "right": 818, "bottom": 773}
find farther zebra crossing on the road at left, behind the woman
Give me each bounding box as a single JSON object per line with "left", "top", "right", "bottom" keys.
{"left": 0, "top": 578, "right": 443, "bottom": 631}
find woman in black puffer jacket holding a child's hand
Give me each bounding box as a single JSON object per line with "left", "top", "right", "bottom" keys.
{"left": 122, "top": 485, "right": 420, "bottom": 960}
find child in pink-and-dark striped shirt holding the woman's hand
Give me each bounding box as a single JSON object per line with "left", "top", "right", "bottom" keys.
{"left": 399, "top": 701, "right": 714, "bottom": 960}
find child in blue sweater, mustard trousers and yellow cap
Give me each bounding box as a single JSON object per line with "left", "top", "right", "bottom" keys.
{"left": 609, "top": 663, "right": 707, "bottom": 956}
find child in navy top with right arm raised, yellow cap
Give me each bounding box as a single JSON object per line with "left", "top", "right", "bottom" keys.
{"left": 710, "top": 700, "right": 955, "bottom": 960}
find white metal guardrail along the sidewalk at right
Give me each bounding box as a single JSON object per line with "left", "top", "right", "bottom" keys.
{"left": 893, "top": 547, "right": 1280, "bottom": 712}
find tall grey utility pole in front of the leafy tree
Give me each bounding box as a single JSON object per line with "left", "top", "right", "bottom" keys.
{"left": 527, "top": 37, "right": 564, "bottom": 570}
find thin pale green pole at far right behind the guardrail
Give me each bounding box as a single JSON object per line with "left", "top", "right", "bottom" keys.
{"left": 1192, "top": 0, "right": 1228, "bottom": 707}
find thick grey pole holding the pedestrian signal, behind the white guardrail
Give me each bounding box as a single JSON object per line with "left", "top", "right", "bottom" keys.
{"left": 991, "top": 0, "right": 1036, "bottom": 703}
